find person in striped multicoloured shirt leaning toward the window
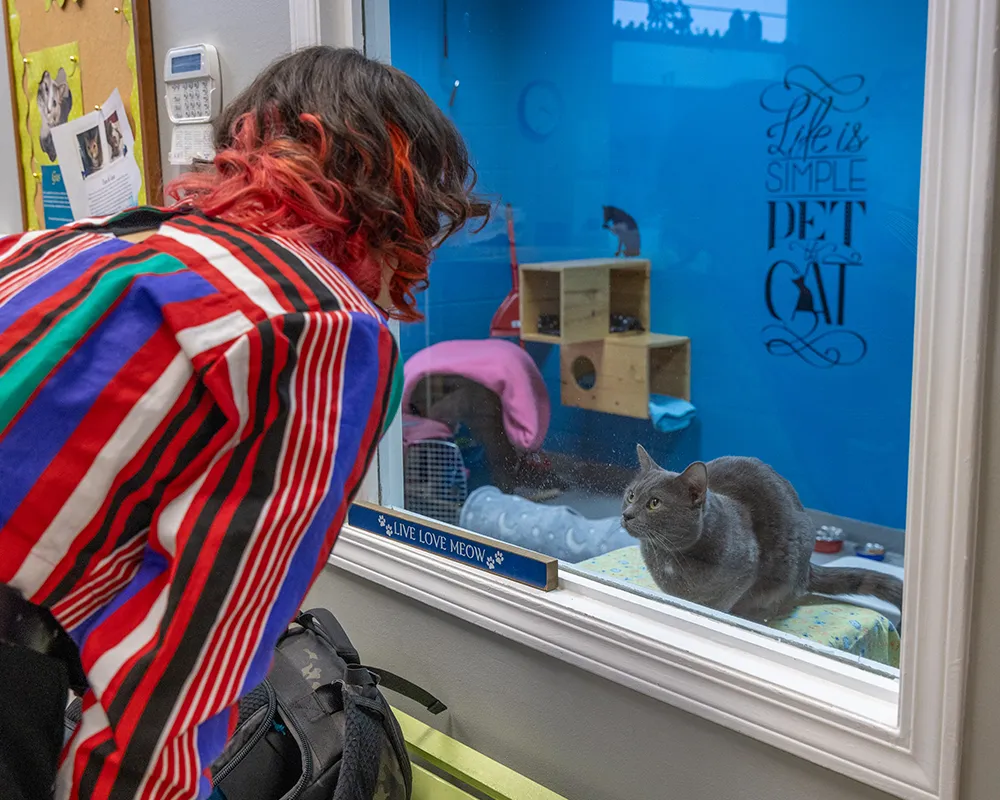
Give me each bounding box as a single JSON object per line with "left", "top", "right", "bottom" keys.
{"left": 0, "top": 47, "right": 485, "bottom": 800}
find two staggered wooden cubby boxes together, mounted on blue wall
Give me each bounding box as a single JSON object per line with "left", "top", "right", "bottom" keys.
{"left": 519, "top": 258, "right": 691, "bottom": 419}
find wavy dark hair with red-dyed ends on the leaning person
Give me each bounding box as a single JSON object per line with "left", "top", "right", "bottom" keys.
{"left": 167, "top": 47, "right": 486, "bottom": 320}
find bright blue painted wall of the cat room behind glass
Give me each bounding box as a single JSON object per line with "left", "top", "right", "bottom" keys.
{"left": 390, "top": 0, "right": 926, "bottom": 527}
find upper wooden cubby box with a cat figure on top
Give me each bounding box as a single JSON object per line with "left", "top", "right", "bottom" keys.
{"left": 519, "top": 258, "right": 649, "bottom": 344}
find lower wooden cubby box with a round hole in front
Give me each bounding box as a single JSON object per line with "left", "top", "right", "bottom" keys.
{"left": 559, "top": 333, "right": 691, "bottom": 419}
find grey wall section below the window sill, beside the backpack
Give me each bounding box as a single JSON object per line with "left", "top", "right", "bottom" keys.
{"left": 307, "top": 569, "right": 900, "bottom": 800}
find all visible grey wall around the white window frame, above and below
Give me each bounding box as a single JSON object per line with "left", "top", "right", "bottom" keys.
{"left": 143, "top": 6, "right": 1000, "bottom": 800}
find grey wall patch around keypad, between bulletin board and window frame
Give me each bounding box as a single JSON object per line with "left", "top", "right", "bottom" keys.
{"left": 150, "top": 0, "right": 291, "bottom": 182}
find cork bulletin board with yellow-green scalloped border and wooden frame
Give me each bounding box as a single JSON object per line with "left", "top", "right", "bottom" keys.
{"left": 0, "top": 0, "right": 162, "bottom": 229}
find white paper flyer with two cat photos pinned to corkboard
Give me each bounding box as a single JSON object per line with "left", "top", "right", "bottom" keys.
{"left": 52, "top": 89, "right": 142, "bottom": 219}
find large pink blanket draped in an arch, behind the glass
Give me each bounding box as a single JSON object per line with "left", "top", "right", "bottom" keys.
{"left": 402, "top": 339, "right": 551, "bottom": 453}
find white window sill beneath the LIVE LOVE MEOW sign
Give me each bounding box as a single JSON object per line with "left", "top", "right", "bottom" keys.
{"left": 330, "top": 528, "right": 939, "bottom": 800}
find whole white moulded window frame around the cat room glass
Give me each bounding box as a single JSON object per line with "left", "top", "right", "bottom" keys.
{"left": 324, "top": 0, "right": 1000, "bottom": 800}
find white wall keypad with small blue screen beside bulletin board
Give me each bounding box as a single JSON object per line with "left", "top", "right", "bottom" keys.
{"left": 163, "top": 44, "right": 222, "bottom": 125}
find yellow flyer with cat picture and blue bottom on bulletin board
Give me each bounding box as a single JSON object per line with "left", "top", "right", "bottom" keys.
{"left": 21, "top": 42, "right": 83, "bottom": 228}
